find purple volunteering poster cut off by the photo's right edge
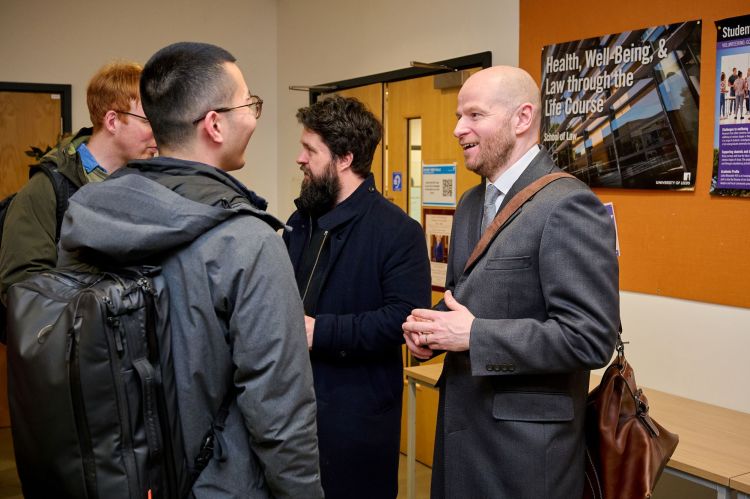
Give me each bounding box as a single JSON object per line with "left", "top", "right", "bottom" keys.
{"left": 710, "top": 15, "right": 750, "bottom": 198}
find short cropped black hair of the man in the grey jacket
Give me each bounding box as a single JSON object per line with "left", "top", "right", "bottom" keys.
{"left": 140, "top": 42, "right": 237, "bottom": 147}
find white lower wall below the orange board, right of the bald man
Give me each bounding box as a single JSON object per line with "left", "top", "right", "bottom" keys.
{"left": 620, "top": 292, "right": 750, "bottom": 412}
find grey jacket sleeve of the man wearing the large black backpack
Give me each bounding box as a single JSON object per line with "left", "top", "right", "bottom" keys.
{"left": 229, "top": 230, "right": 323, "bottom": 498}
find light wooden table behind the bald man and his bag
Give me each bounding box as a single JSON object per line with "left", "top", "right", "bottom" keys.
{"left": 404, "top": 364, "right": 750, "bottom": 499}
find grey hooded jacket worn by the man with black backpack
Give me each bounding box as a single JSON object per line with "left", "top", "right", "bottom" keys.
{"left": 58, "top": 157, "right": 323, "bottom": 499}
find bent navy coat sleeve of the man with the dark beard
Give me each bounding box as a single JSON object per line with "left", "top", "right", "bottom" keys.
{"left": 312, "top": 222, "right": 430, "bottom": 358}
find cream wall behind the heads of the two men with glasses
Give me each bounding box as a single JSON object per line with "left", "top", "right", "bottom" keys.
{"left": 0, "top": 0, "right": 278, "bottom": 211}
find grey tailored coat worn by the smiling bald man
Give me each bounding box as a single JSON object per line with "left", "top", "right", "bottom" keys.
{"left": 432, "top": 150, "right": 619, "bottom": 499}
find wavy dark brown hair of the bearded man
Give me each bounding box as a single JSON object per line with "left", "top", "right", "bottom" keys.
{"left": 297, "top": 95, "right": 383, "bottom": 177}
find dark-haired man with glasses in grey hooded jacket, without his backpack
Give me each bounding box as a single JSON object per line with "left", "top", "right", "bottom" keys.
{"left": 55, "top": 42, "right": 323, "bottom": 499}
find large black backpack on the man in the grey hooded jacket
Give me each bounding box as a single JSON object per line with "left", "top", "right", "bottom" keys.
{"left": 8, "top": 267, "right": 230, "bottom": 499}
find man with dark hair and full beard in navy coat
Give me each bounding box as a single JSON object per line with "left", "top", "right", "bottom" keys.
{"left": 284, "top": 96, "right": 430, "bottom": 499}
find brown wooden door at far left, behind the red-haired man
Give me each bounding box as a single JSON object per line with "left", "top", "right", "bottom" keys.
{"left": 0, "top": 91, "right": 62, "bottom": 427}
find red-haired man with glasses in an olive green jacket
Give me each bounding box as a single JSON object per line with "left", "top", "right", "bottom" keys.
{"left": 0, "top": 62, "right": 156, "bottom": 301}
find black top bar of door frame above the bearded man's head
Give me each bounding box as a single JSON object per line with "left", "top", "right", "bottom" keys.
{"left": 309, "top": 51, "right": 492, "bottom": 105}
